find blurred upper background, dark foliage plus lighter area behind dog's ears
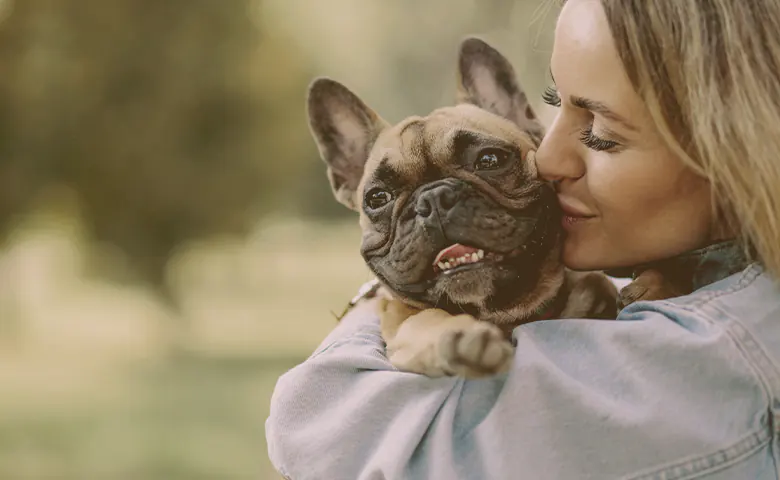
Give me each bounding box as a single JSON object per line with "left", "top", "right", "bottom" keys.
{"left": 0, "top": 0, "right": 551, "bottom": 292}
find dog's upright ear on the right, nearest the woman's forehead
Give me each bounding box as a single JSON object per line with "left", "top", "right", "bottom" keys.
{"left": 458, "top": 37, "right": 544, "bottom": 140}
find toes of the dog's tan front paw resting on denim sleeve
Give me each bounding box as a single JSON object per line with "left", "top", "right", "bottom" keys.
{"left": 438, "top": 322, "right": 514, "bottom": 378}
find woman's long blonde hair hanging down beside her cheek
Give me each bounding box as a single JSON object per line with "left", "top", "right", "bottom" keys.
{"left": 601, "top": 0, "right": 780, "bottom": 279}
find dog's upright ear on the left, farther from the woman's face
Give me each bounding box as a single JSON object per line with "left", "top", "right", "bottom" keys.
{"left": 307, "top": 78, "right": 388, "bottom": 210}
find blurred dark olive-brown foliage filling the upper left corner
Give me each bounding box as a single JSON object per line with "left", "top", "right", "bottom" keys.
{"left": 0, "top": 0, "right": 311, "bottom": 283}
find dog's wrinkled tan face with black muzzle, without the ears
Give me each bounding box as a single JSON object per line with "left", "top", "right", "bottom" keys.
{"left": 358, "top": 105, "right": 560, "bottom": 310}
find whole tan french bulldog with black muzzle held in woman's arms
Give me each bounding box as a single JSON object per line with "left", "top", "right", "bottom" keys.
{"left": 308, "top": 38, "right": 617, "bottom": 378}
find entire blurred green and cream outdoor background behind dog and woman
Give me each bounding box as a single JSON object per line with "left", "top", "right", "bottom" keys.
{"left": 0, "top": 0, "right": 556, "bottom": 480}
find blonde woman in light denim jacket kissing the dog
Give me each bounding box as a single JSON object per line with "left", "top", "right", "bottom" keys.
{"left": 267, "top": 0, "right": 780, "bottom": 480}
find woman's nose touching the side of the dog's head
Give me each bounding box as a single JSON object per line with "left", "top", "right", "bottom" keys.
{"left": 535, "top": 113, "right": 585, "bottom": 181}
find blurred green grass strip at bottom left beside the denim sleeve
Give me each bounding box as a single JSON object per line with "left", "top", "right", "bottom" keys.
{"left": 0, "top": 355, "right": 302, "bottom": 480}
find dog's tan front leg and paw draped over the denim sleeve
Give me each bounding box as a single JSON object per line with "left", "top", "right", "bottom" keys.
{"left": 379, "top": 298, "right": 514, "bottom": 378}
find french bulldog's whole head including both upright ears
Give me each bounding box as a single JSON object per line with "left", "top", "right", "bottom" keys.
{"left": 308, "top": 38, "right": 563, "bottom": 321}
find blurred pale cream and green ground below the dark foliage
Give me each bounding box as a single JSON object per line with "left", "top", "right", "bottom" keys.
{"left": 0, "top": 216, "right": 369, "bottom": 480}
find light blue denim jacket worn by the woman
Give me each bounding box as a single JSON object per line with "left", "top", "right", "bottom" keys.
{"left": 266, "top": 244, "right": 780, "bottom": 480}
